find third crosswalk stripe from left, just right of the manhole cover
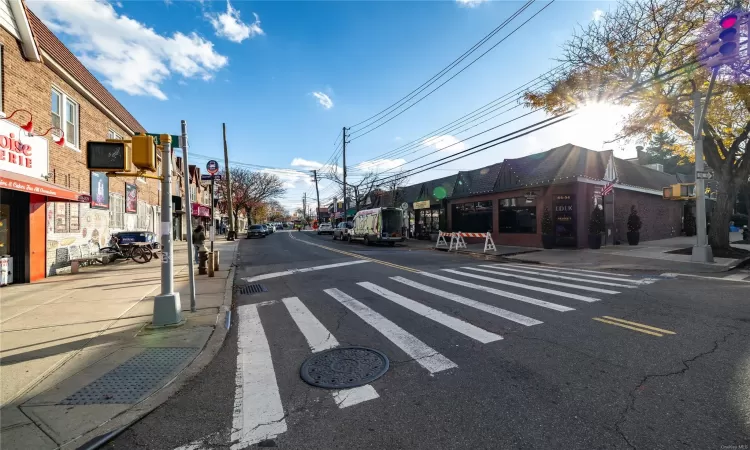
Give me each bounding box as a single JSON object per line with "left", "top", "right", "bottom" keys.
{"left": 323, "top": 288, "right": 458, "bottom": 373}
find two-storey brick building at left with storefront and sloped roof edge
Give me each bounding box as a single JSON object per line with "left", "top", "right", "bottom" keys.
{"left": 0, "top": 0, "right": 160, "bottom": 283}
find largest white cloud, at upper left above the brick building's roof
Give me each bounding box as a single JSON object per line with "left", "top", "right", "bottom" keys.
{"left": 29, "top": 0, "right": 228, "bottom": 100}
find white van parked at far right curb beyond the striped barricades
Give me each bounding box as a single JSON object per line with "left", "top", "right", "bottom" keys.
{"left": 349, "top": 208, "right": 404, "bottom": 246}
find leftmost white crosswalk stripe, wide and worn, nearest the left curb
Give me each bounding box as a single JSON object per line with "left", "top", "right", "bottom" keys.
{"left": 231, "top": 305, "right": 287, "bottom": 450}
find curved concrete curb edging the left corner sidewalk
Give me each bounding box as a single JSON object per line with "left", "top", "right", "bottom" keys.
{"left": 67, "top": 243, "right": 239, "bottom": 450}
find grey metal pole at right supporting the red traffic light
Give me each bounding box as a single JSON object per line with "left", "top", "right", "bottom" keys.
{"left": 690, "top": 83, "right": 716, "bottom": 263}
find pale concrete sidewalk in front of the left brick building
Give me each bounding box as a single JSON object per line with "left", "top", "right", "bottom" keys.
{"left": 0, "top": 241, "right": 239, "bottom": 450}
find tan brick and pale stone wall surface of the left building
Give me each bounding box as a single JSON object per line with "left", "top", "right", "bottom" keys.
{"left": 0, "top": 28, "right": 160, "bottom": 274}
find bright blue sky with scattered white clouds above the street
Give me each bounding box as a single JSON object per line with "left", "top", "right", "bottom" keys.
{"left": 28, "top": 0, "right": 635, "bottom": 214}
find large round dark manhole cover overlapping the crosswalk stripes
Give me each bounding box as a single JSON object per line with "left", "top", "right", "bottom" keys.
{"left": 300, "top": 347, "right": 389, "bottom": 389}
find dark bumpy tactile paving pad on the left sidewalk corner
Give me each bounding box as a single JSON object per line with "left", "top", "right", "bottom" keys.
{"left": 60, "top": 347, "right": 196, "bottom": 405}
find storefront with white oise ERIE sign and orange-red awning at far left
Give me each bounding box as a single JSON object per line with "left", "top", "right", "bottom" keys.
{"left": 0, "top": 120, "right": 83, "bottom": 283}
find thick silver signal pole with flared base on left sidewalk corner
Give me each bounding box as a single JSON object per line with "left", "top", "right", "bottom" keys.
{"left": 152, "top": 139, "right": 182, "bottom": 326}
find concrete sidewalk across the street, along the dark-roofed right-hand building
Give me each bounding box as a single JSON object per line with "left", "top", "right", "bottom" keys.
{"left": 405, "top": 233, "right": 750, "bottom": 273}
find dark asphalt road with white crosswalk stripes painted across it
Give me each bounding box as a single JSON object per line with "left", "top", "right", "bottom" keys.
{"left": 107, "top": 232, "right": 750, "bottom": 450}
